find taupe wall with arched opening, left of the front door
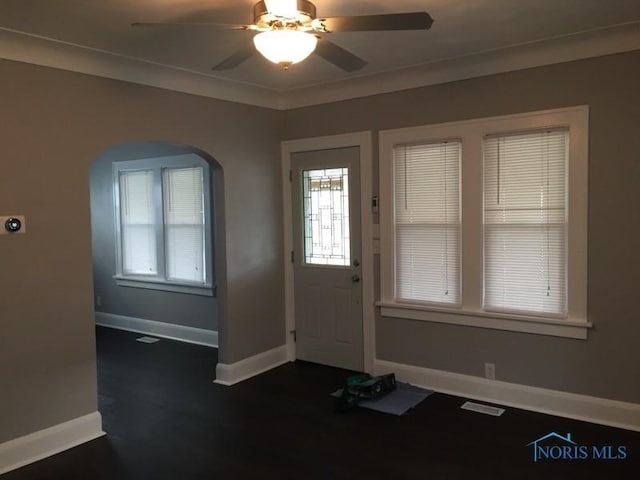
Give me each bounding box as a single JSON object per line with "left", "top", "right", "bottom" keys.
{"left": 0, "top": 60, "right": 285, "bottom": 443}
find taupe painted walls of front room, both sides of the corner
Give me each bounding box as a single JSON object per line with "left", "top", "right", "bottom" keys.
{"left": 0, "top": 48, "right": 640, "bottom": 450}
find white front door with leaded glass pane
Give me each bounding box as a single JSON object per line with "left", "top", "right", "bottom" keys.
{"left": 291, "top": 147, "right": 364, "bottom": 371}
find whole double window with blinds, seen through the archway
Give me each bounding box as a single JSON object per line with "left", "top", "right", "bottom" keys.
{"left": 113, "top": 154, "right": 213, "bottom": 296}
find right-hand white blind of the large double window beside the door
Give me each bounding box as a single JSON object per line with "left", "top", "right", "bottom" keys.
{"left": 483, "top": 129, "right": 568, "bottom": 317}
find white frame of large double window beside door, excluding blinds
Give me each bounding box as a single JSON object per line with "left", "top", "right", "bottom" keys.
{"left": 377, "top": 106, "right": 592, "bottom": 339}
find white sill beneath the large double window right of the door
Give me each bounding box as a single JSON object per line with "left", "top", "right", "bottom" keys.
{"left": 376, "top": 301, "right": 593, "bottom": 340}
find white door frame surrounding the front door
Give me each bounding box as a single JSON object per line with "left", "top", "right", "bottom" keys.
{"left": 281, "top": 131, "right": 375, "bottom": 373}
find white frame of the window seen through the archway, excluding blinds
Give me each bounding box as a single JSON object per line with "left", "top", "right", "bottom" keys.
{"left": 113, "top": 153, "right": 215, "bottom": 296}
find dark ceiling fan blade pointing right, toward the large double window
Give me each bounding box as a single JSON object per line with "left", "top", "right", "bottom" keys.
{"left": 319, "top": 12, "right": 433, "bottom": 32}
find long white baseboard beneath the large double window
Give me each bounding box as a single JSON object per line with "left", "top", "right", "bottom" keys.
{"left": 374, "top": 359, "right": 640, "bottom": 431}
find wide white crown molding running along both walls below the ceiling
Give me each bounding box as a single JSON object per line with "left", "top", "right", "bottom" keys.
{"left": 0, "top": 21, "right": 640, "bottom": 110}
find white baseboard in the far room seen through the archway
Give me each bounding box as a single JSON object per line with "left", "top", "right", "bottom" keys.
{"left": 96, "top": 312, "right": 218, "bottom": 348}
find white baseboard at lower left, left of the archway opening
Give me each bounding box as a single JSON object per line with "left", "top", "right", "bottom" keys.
{"left": 0, "top": 411, "right": 105, "bottom": 475}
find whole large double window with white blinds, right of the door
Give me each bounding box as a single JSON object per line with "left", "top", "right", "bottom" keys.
{"left": 377, "top": 106, "right": 591, "bottom": 339}
